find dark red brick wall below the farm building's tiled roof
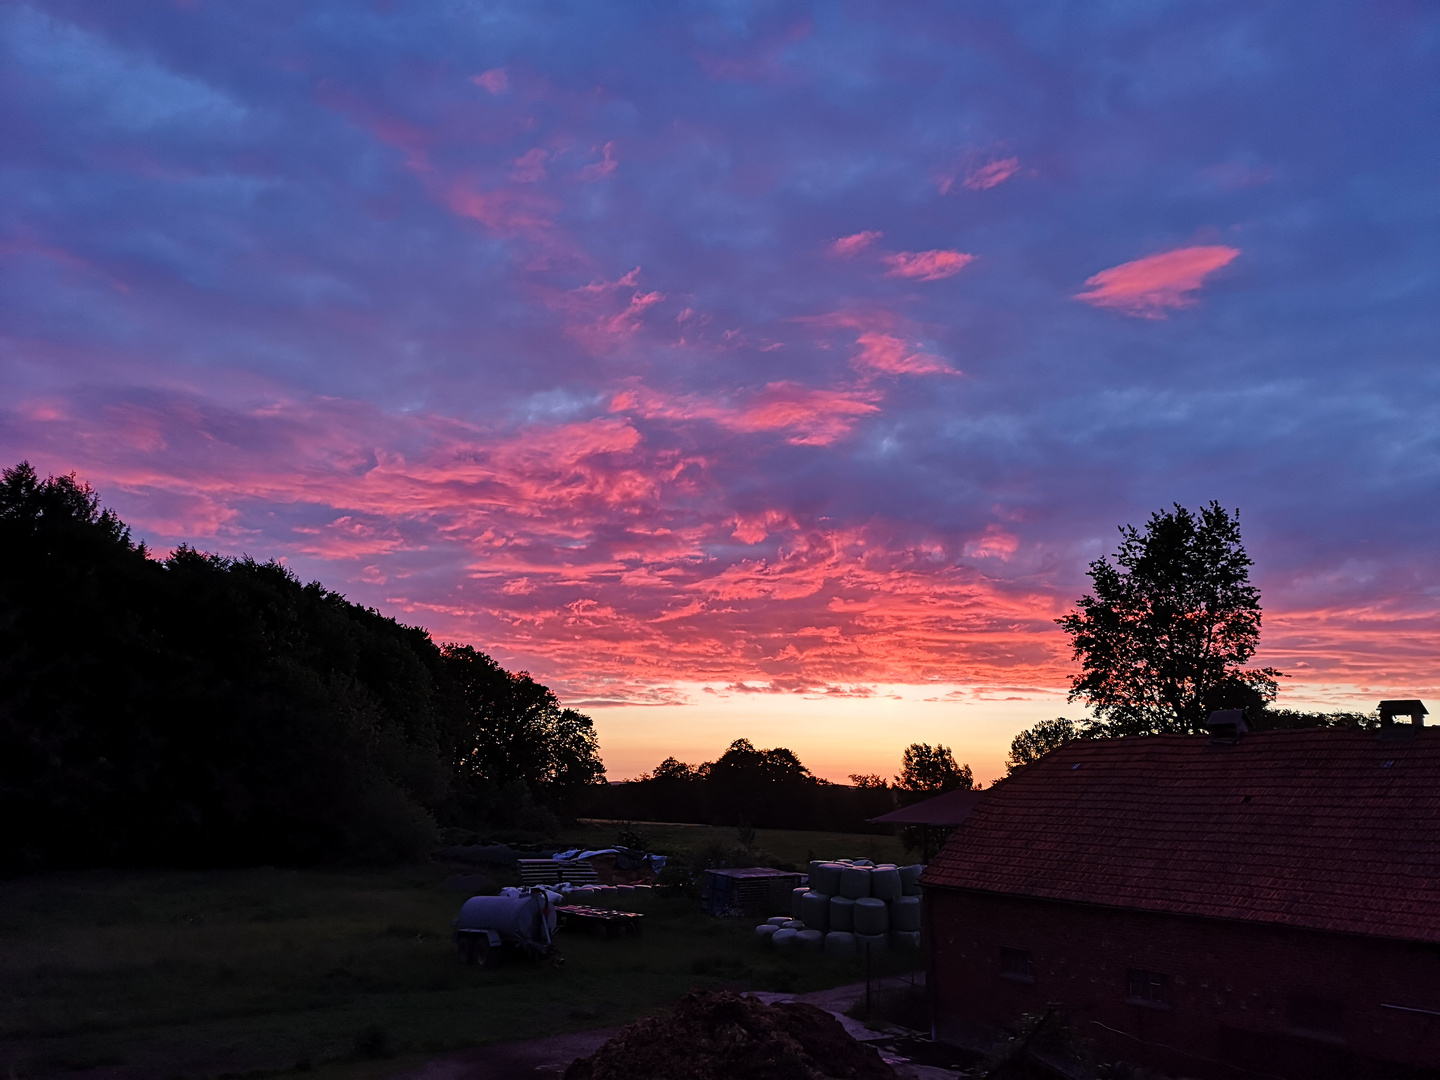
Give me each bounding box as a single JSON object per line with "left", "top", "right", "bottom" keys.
{"left": 924, "top": 888, "right": 1440, "bottom": 1080}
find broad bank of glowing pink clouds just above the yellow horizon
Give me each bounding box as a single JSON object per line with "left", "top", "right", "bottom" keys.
{"left": 22, "top": 385, "right": 1440, "bottom": 714}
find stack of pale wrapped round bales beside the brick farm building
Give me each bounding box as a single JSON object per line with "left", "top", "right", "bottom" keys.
{"left": 755, "top": 858, "right": 924, "bottom": 956}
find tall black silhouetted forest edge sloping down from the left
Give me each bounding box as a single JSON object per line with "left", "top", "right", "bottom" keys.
{"left": 0, "top": 462, "right": 605, "bottom": 870}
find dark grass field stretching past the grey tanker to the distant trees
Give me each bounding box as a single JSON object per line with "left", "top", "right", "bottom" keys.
{"left": 0, "top": 827, "right": 917, "bottom": 1080}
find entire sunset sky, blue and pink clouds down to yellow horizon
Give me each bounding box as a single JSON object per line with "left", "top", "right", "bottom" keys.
{"left": 0, "top": 0, "right": 1440, "bottom": 780}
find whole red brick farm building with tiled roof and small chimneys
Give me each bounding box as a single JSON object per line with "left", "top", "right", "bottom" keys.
{"left": 922, "top": 701, "right": 1440, "bottom": 1077}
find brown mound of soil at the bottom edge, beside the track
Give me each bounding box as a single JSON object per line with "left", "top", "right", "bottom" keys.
{"left": 564, "top": 991, "right": 894, "bottom": 1080}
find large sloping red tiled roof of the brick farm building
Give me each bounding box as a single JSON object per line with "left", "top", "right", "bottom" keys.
{"left": 922, "top": 727, "right": 1440, "bottom": 942}
